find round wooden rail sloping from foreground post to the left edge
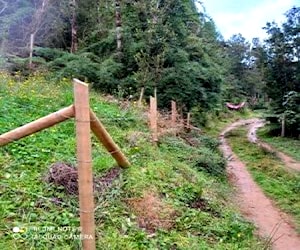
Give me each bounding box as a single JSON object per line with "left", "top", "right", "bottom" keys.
{"left": 0, "top": 105, "right": 75, "bottom": 146}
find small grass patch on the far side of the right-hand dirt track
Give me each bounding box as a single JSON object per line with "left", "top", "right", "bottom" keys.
{"left": 258, "top": 128, "right": 300, "bottom": 161}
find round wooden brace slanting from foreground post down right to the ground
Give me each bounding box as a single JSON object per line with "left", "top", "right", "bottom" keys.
{"left": 90, "top": 110, "right": 130, "bottom": 168}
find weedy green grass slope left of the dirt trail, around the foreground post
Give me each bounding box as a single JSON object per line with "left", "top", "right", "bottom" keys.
{"left": 0, "top": 73, "right": 262, "bottom": 250}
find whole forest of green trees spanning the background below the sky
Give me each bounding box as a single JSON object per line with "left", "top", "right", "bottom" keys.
{"left": 0, "top": 0, "right": 300, "bottom": 137}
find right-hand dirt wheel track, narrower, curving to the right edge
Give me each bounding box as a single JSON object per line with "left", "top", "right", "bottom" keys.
{"left": 247, "top": 119, "right": 300, "bottom": 172}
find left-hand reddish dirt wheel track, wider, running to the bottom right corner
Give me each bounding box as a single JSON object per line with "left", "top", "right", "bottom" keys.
{"left": 220, "top": 119, "right": 300, "bottom": 250}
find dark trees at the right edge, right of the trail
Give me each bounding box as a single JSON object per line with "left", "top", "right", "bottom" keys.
{"left": 265, "top": 7, "right": 300, "bottom": 136}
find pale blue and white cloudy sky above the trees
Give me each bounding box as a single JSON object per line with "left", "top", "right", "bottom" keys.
{"left": 200, "top": 0, "right": 300, "bottom": 41}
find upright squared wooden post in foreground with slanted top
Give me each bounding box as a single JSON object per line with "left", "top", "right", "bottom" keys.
{"left": 73, "top": 79, "right": 96, "bottom": 250}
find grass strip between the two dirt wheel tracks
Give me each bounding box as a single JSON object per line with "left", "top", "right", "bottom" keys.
{"left": 228, "top": 129, "right": 300, "bottom": 231}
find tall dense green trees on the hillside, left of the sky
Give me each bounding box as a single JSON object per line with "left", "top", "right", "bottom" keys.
{"left": 1, "top": 0, "right": 223, "bottom": 114}
